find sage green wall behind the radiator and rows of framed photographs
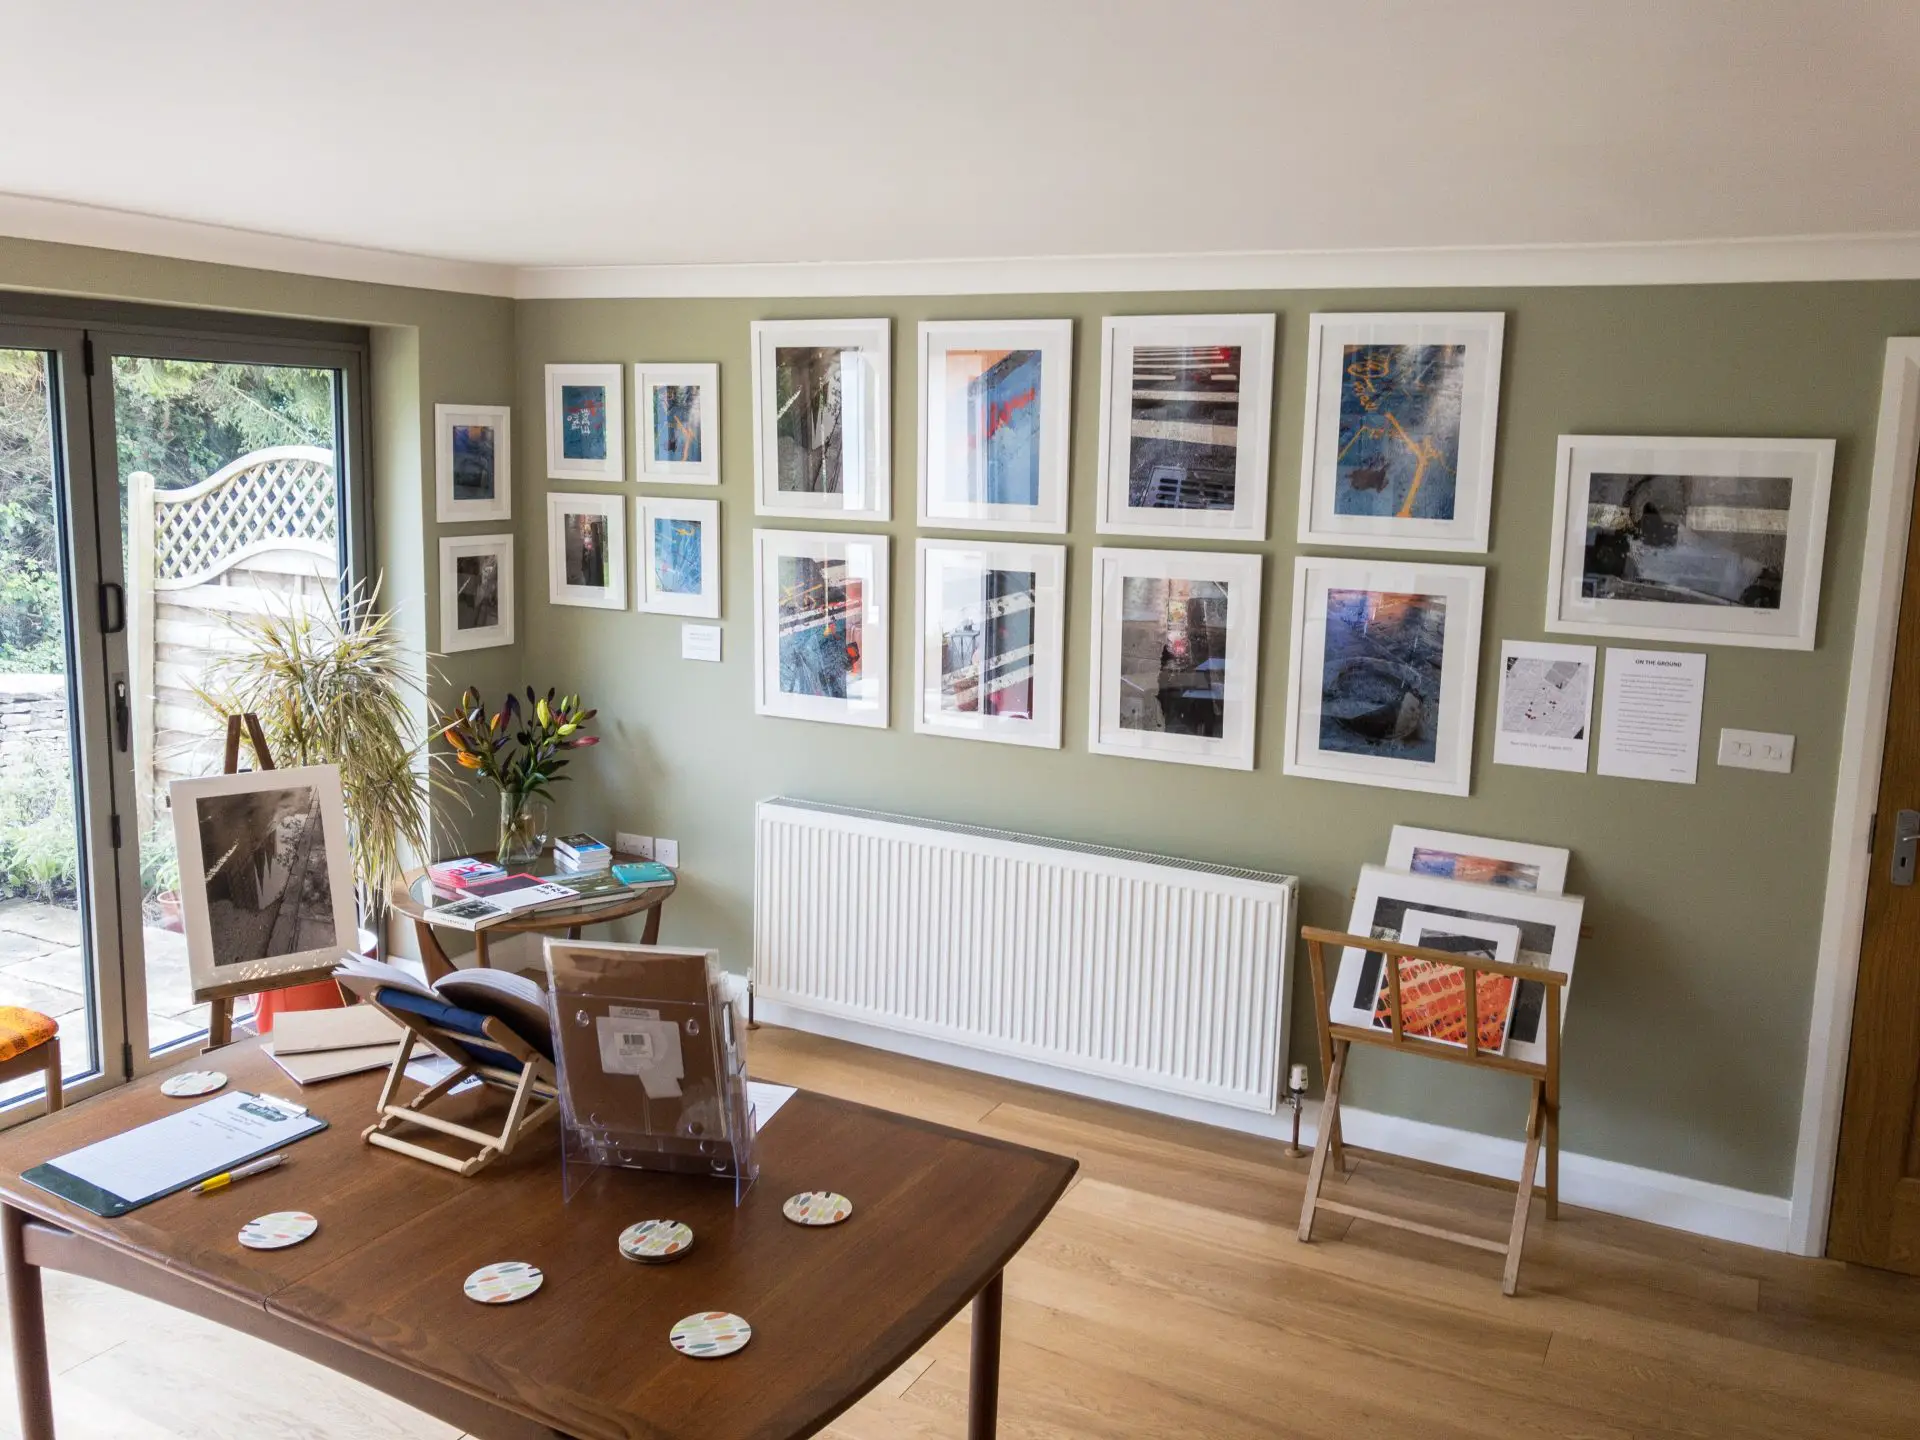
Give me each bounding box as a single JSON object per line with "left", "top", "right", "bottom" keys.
{"left": 515, "top": 284, "right": 1920, "bottom": 1194}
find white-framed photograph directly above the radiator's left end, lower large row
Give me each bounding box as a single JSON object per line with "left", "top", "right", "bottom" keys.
{"left": 753, "top": 530, "right": 889, "bottom": 730}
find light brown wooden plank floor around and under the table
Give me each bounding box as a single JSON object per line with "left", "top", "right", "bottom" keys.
{"left": 0, "top": 1029, "right": 1920, "bottom": 1440}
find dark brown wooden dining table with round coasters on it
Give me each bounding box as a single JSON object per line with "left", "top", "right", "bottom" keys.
{"left": 0, "top": 1041, "right": 1077, "bottom": 1440}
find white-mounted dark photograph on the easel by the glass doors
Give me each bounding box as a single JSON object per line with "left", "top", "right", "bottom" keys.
{"left": 167, "top": 764, "right": 359, "bottom": 1000}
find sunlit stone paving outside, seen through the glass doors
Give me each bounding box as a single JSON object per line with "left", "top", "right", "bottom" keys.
{"left": 0, "top": 900, "right": 222, "bottom": 1102}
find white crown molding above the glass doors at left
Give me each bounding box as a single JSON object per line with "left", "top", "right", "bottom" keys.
{"left": 0, "top": 194, "right": 515, "bottom": 298}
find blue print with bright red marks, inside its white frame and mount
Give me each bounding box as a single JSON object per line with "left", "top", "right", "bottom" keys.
{"left": 939, "top": 349, "right": 1041, "bottom": 505}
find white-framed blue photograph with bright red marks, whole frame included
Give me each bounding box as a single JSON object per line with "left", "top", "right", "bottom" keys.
{"left": 920, "top": 321, "right": 1073, "bottom": 536}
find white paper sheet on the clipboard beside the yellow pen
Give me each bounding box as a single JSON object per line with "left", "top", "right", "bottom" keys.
{"left": 48, "top": 1091, "right": 317, "bottom": 1204}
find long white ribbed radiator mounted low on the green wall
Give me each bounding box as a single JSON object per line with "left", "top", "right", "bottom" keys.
{"left": 753, "top": 799, "right": 1296, "bottom": 1114}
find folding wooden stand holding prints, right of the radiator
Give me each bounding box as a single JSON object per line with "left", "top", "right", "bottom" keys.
{"left": 1300, "top": 925, "right": 1567, "bottom": 1294}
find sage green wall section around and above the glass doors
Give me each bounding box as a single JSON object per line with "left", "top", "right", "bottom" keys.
{"left": 0, "top": 238, "right": 518, "bottom": 867}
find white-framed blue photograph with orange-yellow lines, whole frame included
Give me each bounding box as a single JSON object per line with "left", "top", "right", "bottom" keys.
{"left": 1300, "top": 311, "right": 1507, "bottom": 555}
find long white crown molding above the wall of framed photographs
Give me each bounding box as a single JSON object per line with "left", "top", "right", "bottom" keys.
{"left": 513, "top": 234, "right": 1920, "bottom": 300}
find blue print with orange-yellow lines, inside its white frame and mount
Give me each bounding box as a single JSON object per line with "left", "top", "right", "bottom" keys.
{"left": 1332, "top": 346, "right": 1467, "bottom": 520}
